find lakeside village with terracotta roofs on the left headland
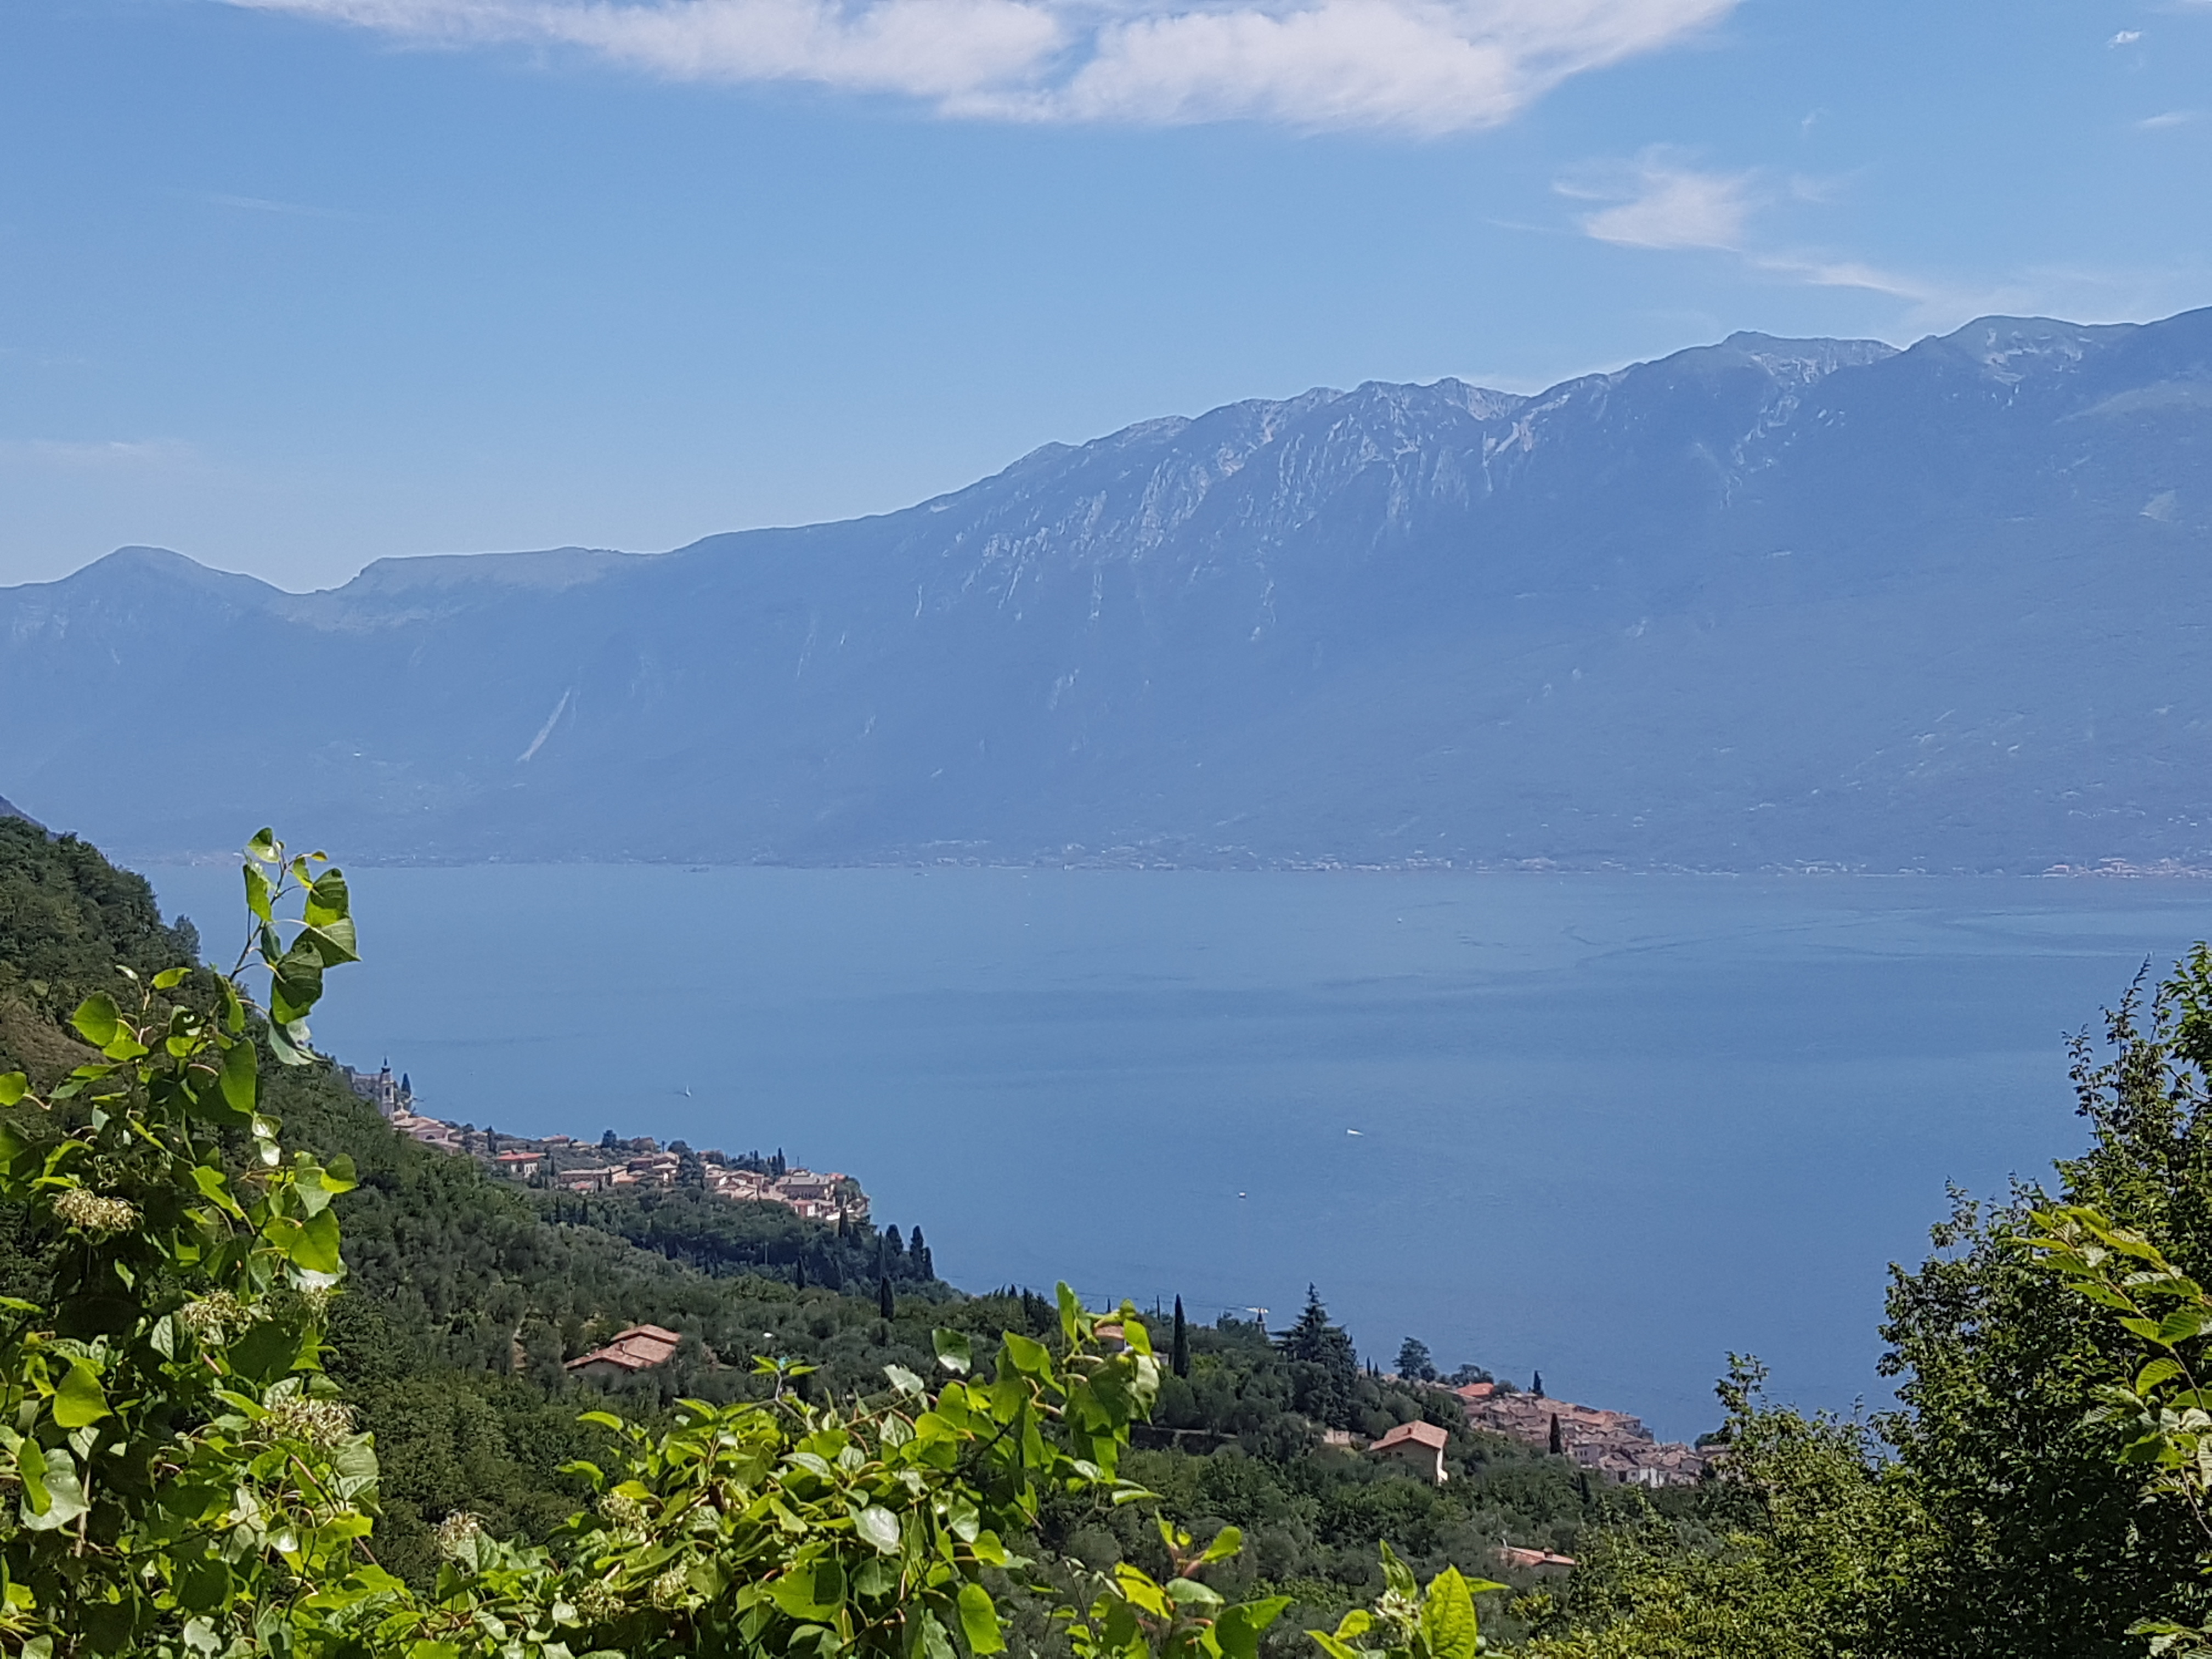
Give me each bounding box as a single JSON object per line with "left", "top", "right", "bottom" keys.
{"left": 338, "top": 1064, "right": 867, "bottom": 1226}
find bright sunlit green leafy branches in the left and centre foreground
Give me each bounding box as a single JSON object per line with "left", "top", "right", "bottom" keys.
{"left": 0, "top": 834, "right": 1513, "bottom": 1659}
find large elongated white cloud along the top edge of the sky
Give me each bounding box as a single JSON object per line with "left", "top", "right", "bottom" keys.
{"left": 230, "top": 0, "right": 1736, "bottom": 133}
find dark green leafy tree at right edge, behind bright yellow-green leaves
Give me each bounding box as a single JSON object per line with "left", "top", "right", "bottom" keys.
{"left": 1882, "top": 945, "right": 2212, "bottom": 1659}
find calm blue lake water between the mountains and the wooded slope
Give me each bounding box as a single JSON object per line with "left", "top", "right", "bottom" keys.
{"left": 153, "top": 865, "right": 2212, "bottom": 1436}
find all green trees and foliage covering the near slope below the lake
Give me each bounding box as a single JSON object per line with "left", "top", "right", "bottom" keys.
{"left": 0, "top": 819, "right": 2212, "bottom": 1659}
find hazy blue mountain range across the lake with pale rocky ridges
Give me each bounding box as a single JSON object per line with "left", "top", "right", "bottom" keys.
{"left": 0, "top": 309, "right": 2212, "bottom": 872}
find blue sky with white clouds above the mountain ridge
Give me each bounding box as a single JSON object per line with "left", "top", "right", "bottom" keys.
{"left": 0, "top": 0, "right": 2212, "bottom": 589}
